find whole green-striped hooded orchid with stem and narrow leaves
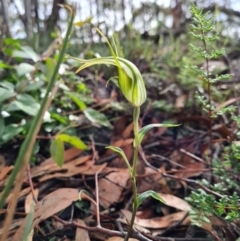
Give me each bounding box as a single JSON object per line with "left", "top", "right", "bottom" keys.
{"left": 71, "top": 30, "right": 177, "bottom": 241}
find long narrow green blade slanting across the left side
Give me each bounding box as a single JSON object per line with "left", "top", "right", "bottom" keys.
{"left": 0, "top": 5, "right": 75, "bottom": 209}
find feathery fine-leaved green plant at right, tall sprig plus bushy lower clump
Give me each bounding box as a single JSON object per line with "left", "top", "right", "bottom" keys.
{"left": 186, "top": 4, "right": 240, "bottom": 226}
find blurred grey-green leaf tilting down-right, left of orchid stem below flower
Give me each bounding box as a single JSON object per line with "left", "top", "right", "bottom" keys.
{"left": 83, "top": 108, "right": 112, "bottom": 128}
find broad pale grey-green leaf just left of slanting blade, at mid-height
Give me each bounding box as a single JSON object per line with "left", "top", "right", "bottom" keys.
{"left": 6, "top": 94, "right": 40, "bottom": 116}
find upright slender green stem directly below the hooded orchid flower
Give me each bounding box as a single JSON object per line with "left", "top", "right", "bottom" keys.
{"left": 124, "top": 107, "right": 140, "bottom": 241}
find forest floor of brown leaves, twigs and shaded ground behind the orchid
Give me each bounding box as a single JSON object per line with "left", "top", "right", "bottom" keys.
{"left": 0, "top": 40, "right": 239, "bottom": 241}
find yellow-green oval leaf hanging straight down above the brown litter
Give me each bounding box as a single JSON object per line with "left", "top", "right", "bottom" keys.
{"left": 50, "top": 138, "right": 64, "bottom": 167}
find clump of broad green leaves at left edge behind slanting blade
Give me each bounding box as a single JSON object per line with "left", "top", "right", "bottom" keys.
{"left": 0, "top": 38, "right": 44, "bottom": 146}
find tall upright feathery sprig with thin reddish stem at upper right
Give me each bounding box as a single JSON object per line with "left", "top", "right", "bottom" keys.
{"left": 189, "top": 3, "right": 232, "bottom": 160}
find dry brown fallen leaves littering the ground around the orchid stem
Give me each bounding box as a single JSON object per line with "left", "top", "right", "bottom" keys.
{"left": 0, "top": 68, "right": 237, "bottom": 241}
